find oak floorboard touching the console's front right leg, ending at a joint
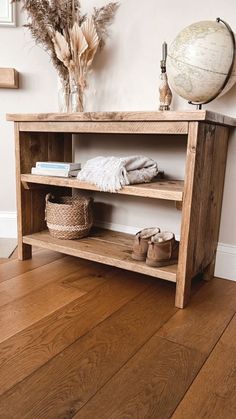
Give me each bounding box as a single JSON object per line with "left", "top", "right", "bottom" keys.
{"left": 158, "top": 278, "right": 236, "bottom": 354}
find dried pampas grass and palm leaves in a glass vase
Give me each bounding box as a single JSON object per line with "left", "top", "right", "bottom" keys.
{"left": 12, "top": 0, "right": 119, "bottom": 112}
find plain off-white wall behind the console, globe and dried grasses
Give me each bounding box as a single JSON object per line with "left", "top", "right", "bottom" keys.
{"left": 0, "top": 0, "right": 236, "bottom": 277}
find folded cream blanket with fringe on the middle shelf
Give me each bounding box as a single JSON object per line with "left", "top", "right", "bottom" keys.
{"left": 78, "top": 156, "right": 158, "bottom": 192}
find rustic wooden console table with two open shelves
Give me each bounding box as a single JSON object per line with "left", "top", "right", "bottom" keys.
{"left": 7, "top": 111, "right": 236, "bottom": 308}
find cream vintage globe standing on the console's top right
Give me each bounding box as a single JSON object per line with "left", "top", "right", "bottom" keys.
{"left": 167, "top": 21, "right": 236, "bottom": 103}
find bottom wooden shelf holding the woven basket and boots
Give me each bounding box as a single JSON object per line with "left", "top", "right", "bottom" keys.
{"left": 23, "top": 228, "right": 177, "bottom": 282}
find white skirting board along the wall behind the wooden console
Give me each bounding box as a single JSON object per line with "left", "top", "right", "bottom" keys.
{"left": 0, "top": 211, "right": 236, "bottom": 281}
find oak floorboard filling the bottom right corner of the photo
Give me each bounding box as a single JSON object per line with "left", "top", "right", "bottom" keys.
{"left": 173, "top": 316, "right": 236, "bottom": 419}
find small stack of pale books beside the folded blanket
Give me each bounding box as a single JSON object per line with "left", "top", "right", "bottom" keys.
{"left": 31, "top": 161, "right": 81, "bottom": 177}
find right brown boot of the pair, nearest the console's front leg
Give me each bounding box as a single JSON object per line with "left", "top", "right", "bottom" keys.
{"left": 146, "top": 231, "right": 179, "bottom": 267}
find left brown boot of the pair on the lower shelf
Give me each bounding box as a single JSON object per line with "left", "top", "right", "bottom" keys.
{"left": 132, "top": 227, "right": 160, "bottom": 260}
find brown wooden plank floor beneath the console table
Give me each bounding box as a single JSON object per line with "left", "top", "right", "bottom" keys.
{"left": 0, "top": 250, "right": 236, "bottom": 419}
